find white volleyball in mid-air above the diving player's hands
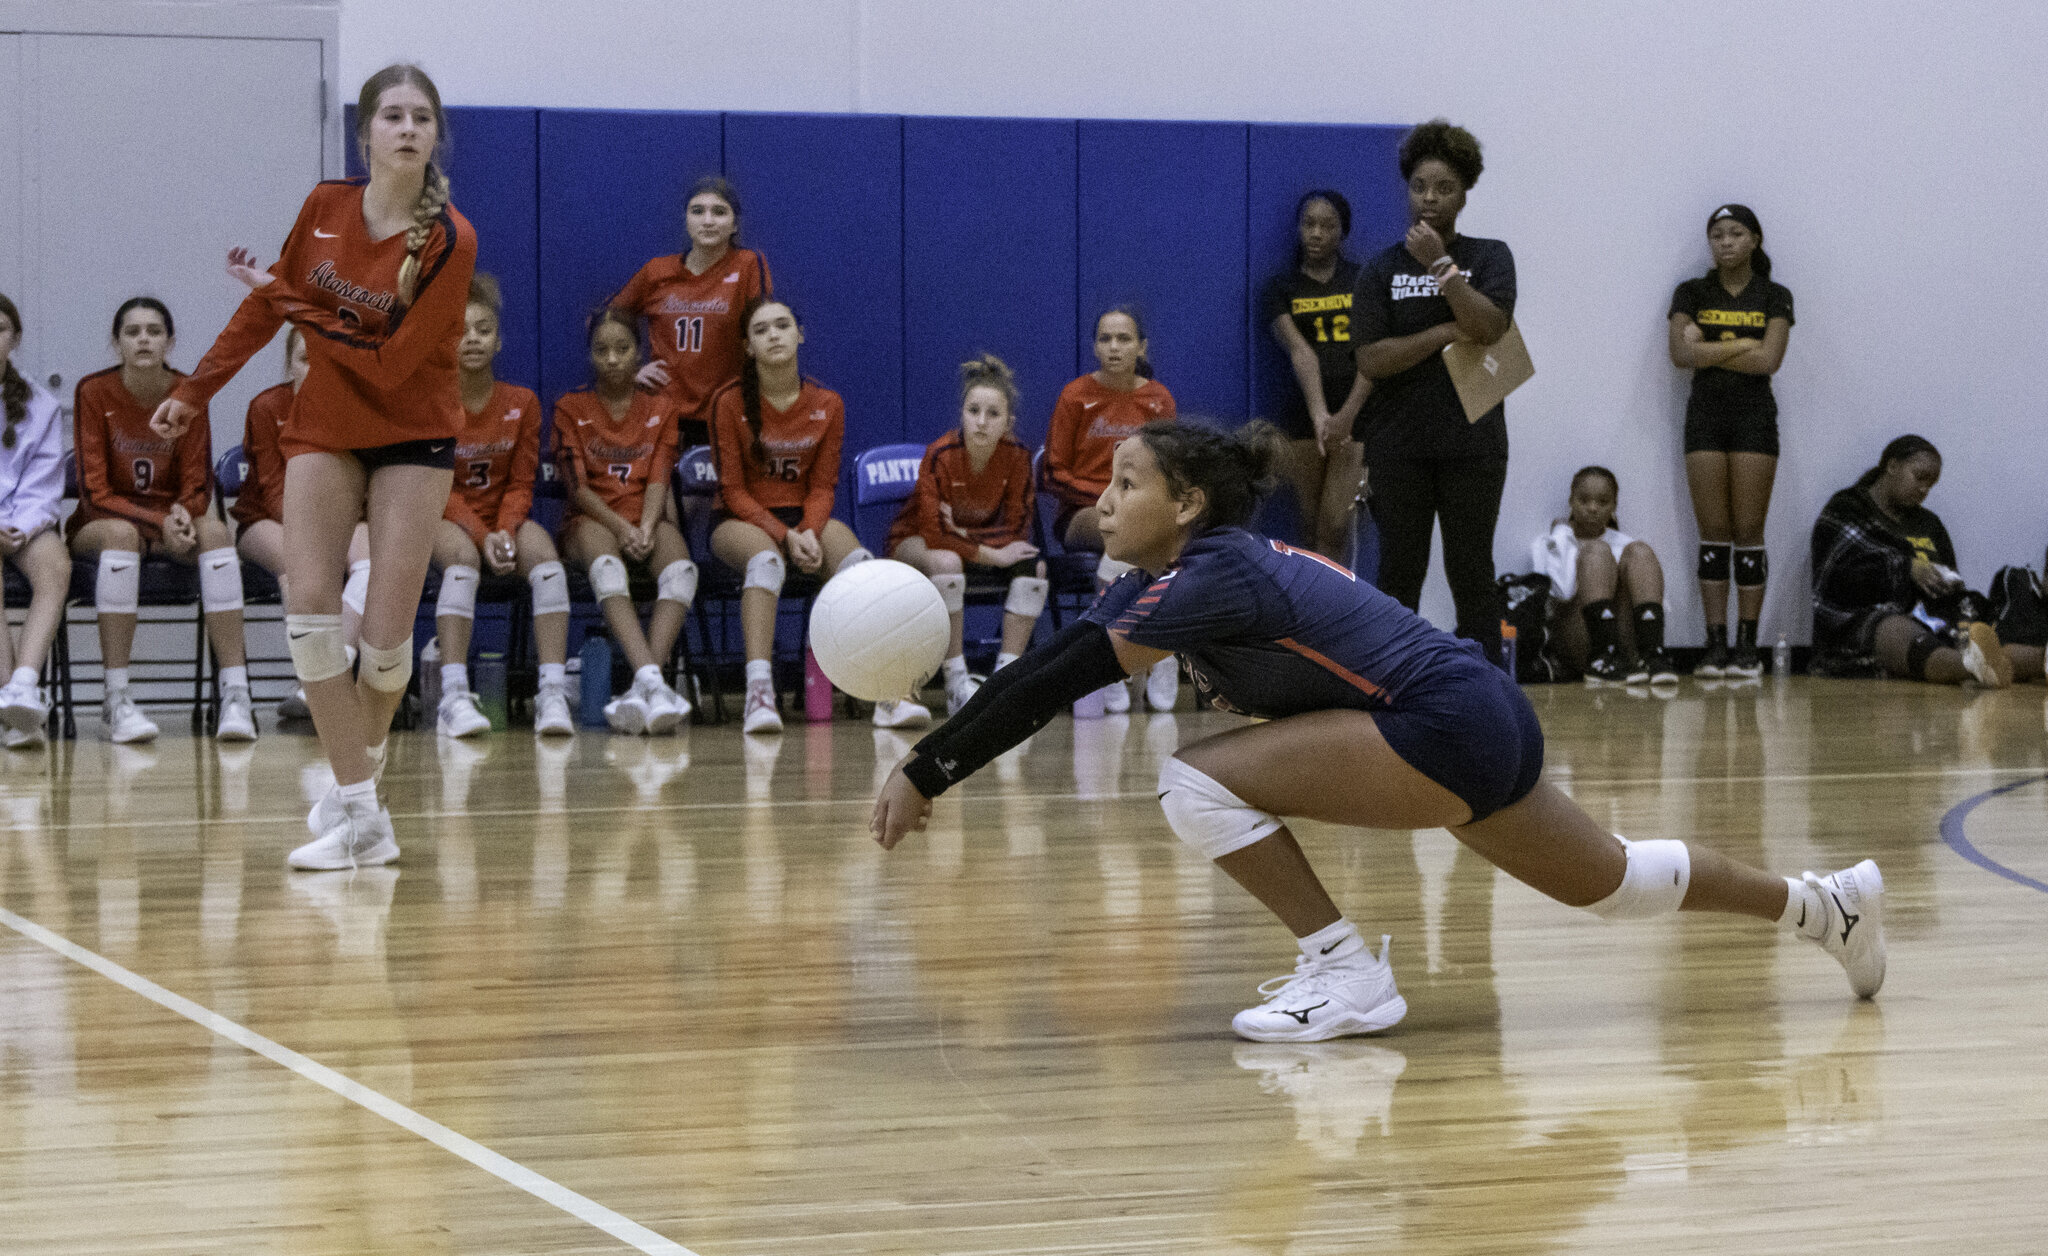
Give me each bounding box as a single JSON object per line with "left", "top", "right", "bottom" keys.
{"left": 811, "top": 557, "right": 952, "bottom": 703}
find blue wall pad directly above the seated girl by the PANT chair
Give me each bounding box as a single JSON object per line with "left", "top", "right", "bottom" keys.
{"left": 903, "top": 117, "right": 1079, "bottom": 445}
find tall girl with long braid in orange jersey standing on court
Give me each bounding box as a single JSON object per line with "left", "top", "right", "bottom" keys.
{"left": 152, "top": 66, "right": 477, "bottom": 869}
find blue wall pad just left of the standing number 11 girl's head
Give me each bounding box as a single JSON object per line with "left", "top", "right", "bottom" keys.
{"left": 537, "top": 109, "right": 720, "bottom": 408}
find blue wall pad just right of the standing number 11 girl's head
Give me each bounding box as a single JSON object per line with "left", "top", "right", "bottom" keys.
{"left": 725, "top": 113, "right": 903, "bottom": 451}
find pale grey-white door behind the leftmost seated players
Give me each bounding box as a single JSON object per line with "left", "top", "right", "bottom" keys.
{"left": 23, "top": 35, "right": 322, "bottom": 455}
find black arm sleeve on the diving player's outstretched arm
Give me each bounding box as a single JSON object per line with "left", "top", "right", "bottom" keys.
{"left": 903, "top": 619, "right": 1124, "bottom": 799}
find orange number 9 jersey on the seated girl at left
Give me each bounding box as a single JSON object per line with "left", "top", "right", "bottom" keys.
{"left": 70, "top": 367, "right": 213, "bottom": 539}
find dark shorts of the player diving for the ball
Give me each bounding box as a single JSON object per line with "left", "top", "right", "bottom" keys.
{"left": 1372, "top": 652, "right": 1542, "bottom": 824}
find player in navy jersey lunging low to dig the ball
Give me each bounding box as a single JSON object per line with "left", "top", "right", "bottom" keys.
{"left": 872, "top": 422, "right": 1884, "bottom": 1043}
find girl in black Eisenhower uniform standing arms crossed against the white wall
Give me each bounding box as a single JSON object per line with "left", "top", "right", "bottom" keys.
{"left": 1669, "top": 205, "right": 1792, "bottom": 676}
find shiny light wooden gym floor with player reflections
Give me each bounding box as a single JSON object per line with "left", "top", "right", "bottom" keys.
{"left": 0, "top": 680, "right": 2048, "bottom": 1256}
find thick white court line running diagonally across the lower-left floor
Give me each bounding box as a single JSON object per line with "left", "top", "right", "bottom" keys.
{"left": 0, "top": 908, "right": 696, "bottom": 1256}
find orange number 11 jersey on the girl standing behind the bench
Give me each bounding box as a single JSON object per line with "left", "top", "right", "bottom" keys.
{"left": 610, "top": 248, "right": 774, "bottom": 422}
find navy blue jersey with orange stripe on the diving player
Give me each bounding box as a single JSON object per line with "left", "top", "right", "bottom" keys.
{"left": 1087, "top": 529, "right": 1491, "bottom": 719}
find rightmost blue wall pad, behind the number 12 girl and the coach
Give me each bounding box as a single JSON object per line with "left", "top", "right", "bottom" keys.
{"left": 1245, "top": 123, "right": 1407, "bottom": 426}
